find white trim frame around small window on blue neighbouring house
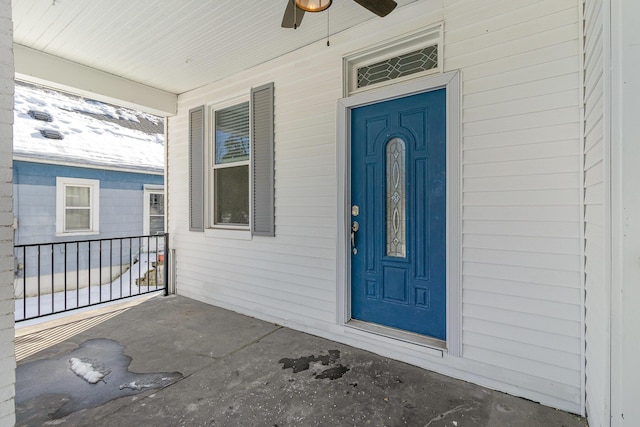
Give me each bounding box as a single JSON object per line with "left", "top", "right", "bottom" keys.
{"left": 56, "top": 176, "right": 100, "bottom": 236}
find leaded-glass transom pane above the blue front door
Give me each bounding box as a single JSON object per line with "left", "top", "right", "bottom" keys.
{"left": 357, "top": 45, "right": 438, "bottom": 88}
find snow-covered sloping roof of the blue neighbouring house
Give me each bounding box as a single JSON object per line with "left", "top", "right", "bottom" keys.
{"left": 13, "top": 82, "right": 164, "bottom": 173}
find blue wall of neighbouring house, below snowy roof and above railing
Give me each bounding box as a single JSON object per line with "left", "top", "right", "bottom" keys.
{"left": 13, "top": 161, "right": 164, "bottom": 245}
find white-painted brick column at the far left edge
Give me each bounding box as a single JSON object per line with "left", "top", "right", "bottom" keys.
{"left": 0, "top": 0, "right": 16, "bottom": 426}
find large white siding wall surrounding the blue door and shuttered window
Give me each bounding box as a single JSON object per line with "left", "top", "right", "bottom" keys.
{"left": 168, "top": 0, "right": 584, "bottom": 413}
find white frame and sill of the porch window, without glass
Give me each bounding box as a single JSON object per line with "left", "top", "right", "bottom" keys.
{"left": 205, "top": 93, "right": 253, "bottom": 236}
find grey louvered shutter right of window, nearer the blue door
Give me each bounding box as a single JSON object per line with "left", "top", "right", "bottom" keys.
{"left": 251, "top": 83, "right": 275, "bottom": 236}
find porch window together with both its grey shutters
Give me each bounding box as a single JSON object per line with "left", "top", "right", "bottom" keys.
{"left": 189, "top": 83, "right": 275, "bottom": 236}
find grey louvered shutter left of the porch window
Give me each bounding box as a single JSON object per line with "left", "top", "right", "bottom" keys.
{"left": 189, "top": 105, "right": 204, "bottom": 231}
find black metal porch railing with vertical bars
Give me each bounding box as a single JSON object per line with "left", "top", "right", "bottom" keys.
{"left": 14, "top": 234, "right": 169, "bottom": 322}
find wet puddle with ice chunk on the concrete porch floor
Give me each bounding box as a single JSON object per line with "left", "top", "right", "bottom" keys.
{"left": 16, "top": 338, "right": 182, "bottom": 421}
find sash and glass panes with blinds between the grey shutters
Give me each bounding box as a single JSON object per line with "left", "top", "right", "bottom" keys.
{"left": 213, "top": 101, "right": 251, "bottom": 228}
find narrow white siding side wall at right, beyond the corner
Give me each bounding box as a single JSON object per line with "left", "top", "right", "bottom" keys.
{"left": 584, "top": 0, "right": 611, "bottom": 427}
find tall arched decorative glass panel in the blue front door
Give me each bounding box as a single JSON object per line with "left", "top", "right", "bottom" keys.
{"left": 386, "top": 138, "right": 407, "bottom": 258}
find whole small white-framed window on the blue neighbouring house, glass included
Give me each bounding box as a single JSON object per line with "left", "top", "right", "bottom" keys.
{"left": 56, "top": 177, "right": 100, "bottom": 234}
